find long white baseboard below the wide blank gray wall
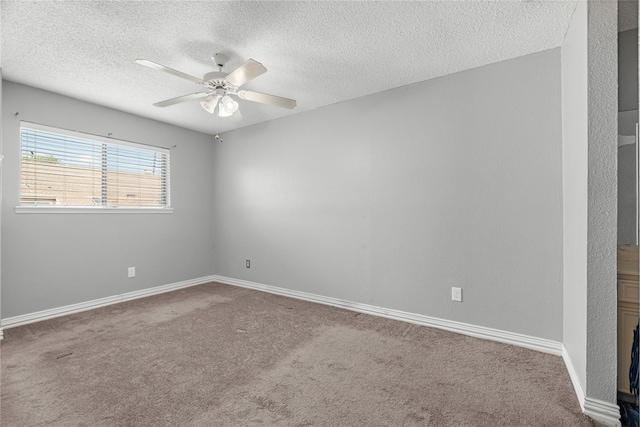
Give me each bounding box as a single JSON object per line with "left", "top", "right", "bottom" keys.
{"left": 212, "top": 275, "right": 562, "bottom": 356}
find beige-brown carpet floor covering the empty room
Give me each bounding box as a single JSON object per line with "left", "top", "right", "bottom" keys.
{"left": 0, "top": 283, "right": 593, "bottom": 427}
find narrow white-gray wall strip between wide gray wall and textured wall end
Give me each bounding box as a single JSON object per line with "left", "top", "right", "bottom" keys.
{"left": 562, "top": 2, "right": 589, "bottom": 393}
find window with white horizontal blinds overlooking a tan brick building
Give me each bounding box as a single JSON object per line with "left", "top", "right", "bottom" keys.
{"left": 20, "top": 122, "right": 170, "bottom": 210}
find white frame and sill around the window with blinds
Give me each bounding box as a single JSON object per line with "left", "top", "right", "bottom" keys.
{"left": 15, "top": 121, "right": 173, "bottom": 213}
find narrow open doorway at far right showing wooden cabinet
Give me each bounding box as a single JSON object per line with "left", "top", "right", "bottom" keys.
{"left": 618, "top": 1, "right": 640, "bottom": 426}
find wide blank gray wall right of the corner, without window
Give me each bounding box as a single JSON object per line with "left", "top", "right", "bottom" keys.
{"left": 214, "top": 49, "right": 563, "bottom": 341}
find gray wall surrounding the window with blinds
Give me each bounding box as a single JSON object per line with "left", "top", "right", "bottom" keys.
{"left": 2, "top": 81, "right": 218, "bottom": 318}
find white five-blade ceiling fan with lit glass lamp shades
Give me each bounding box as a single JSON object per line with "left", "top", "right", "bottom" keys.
{"left": 135, "top": 53, "right": 296, "bottom": 119}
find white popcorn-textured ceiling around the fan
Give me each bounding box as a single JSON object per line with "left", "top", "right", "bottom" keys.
{"left": 0, "top": 0, "right": 575, "bottom": 133}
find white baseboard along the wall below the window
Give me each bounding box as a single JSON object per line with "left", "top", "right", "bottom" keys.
{"left": 0, "top": 276, "right": 214, "bottom": 332}
